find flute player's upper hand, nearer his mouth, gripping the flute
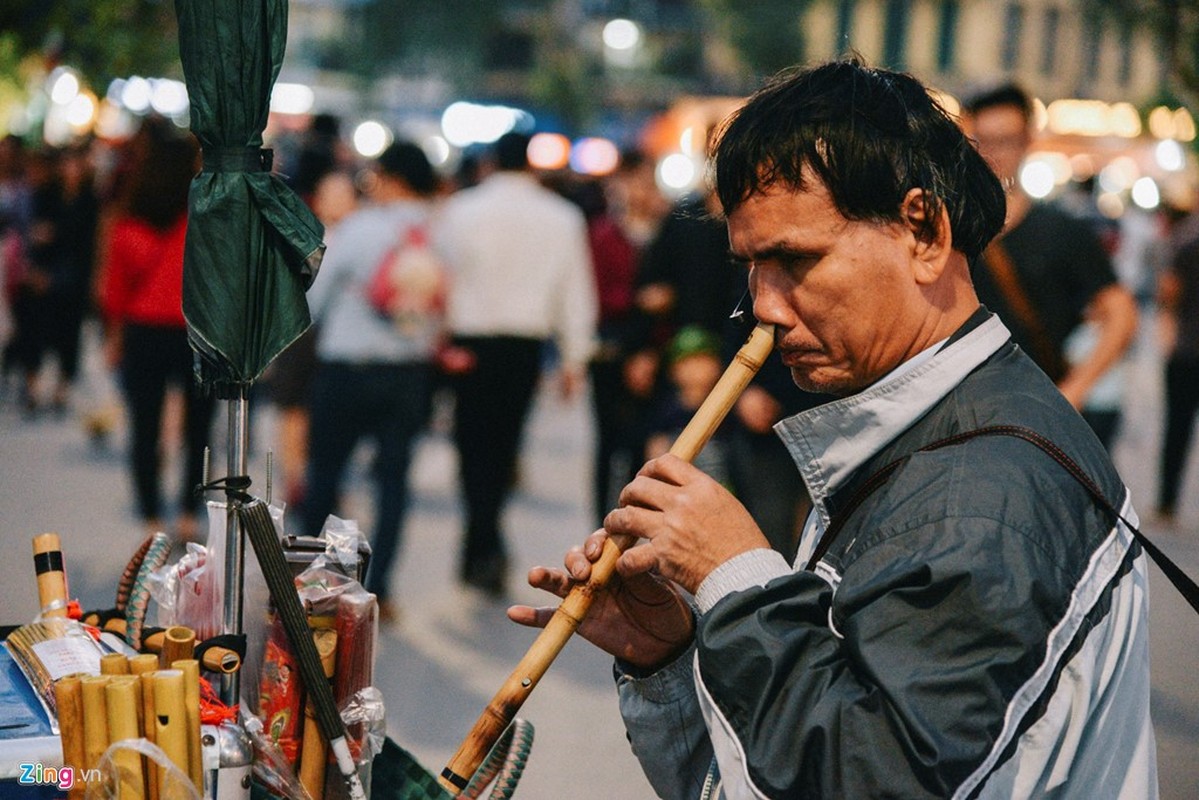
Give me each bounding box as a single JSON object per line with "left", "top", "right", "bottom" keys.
{"left": 604, "top": 455, "right": 770, "bottom": 594}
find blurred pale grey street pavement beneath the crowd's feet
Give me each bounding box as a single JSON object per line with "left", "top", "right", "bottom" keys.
{"left": 0, "top": 325, "right": 1199, "bottom": 800}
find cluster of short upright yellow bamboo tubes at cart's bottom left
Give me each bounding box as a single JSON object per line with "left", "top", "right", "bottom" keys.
{"left": 54, "top": 654, "right": 204, "bottom": 800}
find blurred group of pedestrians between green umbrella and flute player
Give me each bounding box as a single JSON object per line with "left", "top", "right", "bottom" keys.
{"left": 274, "top": 119, "right": 817, "bottom": 616}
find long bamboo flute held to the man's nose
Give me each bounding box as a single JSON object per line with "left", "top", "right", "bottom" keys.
{"left": 438, "top": 323, "right": 775, "bottom": 795}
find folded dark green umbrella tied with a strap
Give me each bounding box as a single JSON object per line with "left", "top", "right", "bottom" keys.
{"left": 175, "top": 0, "right": 325, "bottom": 397}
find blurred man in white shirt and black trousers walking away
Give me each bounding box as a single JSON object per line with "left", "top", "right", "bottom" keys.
{"left": 435, "top": 133, "right": 597, "bottom": 595}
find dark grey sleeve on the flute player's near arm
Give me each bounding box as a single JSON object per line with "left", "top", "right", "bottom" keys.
{"left": 697, "top": 517, "right": 1068, "bottom": 798}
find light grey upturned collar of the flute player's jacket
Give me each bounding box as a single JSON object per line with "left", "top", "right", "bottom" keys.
{"left": 775, "top": 307, "right": 1011, "bottom": 525}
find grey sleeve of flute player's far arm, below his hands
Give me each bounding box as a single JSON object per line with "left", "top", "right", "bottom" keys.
{"left": 614, "top": 648, "right": 712, "bottom": 800}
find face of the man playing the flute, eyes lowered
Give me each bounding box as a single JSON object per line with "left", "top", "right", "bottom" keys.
{"left": 728, "top": 175, "right": 922, "bottom": 396}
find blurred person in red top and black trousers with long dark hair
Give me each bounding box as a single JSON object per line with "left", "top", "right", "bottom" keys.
{"left": 100, "top": 121, "right": 215, "bottom": 541}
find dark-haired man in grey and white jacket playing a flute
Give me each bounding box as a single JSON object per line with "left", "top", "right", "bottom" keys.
{"left": 510, "top": 61, "right": 1157, "bottom": 799}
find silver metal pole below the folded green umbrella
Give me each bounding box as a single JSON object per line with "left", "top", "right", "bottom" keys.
{"left": 221, "top": 384, "right": 249, "bottom": 706}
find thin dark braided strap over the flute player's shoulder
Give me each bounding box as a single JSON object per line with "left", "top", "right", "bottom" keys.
{"left": 807, "top": 425, "right": 1199, "bottom": 613}
